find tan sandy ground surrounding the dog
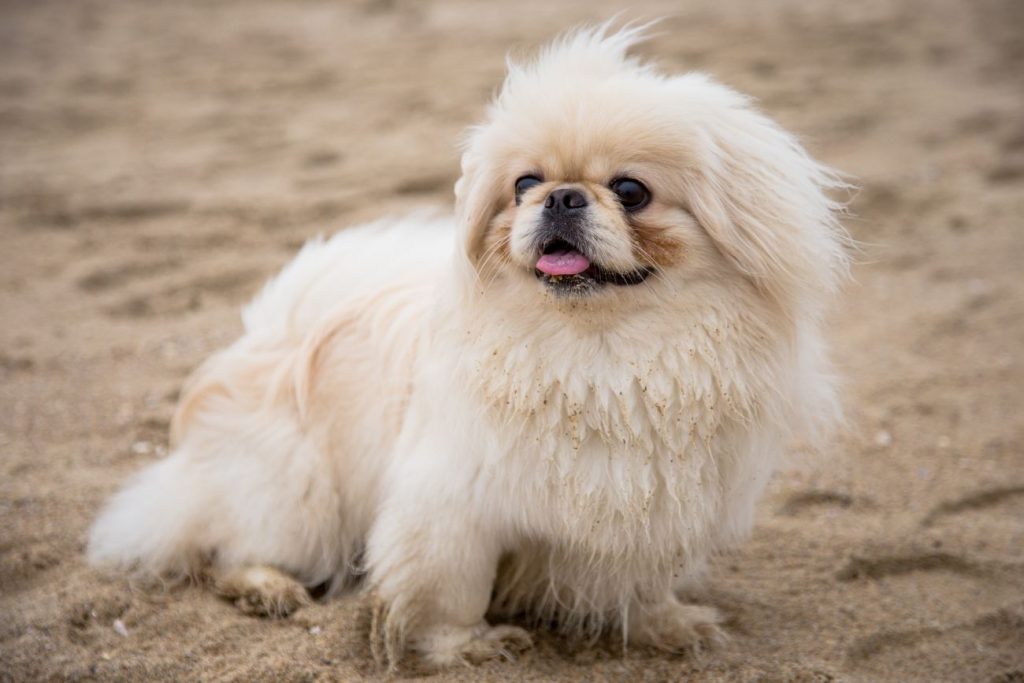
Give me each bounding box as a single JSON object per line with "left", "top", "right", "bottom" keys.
{"left": 0, "top": 0, "right": 1024, "bottom": 683}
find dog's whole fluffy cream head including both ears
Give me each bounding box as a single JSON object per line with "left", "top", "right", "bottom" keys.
{"left": 456, "top": 25, "right": 847, "bottom": 313}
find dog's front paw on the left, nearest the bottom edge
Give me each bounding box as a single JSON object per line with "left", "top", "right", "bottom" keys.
{"left": 413, "top": 624, "right": 534, "bottom": 668}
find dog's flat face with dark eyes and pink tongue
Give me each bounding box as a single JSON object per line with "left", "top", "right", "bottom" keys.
{"left": 480, "top": 118, "right": 717, "bottom": 298}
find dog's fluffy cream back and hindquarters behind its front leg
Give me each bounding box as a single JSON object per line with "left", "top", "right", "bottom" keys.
{"left": 89, "top": 217, "right": 454, "bottom": 585}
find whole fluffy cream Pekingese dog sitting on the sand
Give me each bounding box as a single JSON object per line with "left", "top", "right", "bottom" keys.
{"left": 89, "top": 25, "right": 848, "bottom": 665}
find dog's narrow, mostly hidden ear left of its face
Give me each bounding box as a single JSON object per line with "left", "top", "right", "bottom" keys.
{"left": 455, "top": 136, "right": 499, "bottom": 264}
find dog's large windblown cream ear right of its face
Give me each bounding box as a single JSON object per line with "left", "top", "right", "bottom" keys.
{"left": 687, "top": 83, "right": 850, "bottom": 305}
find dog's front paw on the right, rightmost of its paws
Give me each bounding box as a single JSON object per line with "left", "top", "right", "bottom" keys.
{"left": 630, "top": 600, "right": 728, "bottom": 657}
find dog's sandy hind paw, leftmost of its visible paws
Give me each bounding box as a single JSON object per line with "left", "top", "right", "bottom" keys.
{"left": 205, "top": 566, "right": 310, "bottom": 618}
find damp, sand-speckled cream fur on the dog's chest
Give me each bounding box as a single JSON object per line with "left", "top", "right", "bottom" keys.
{"left": 463, "top": 307, "right": 764, "bottom": 556}
